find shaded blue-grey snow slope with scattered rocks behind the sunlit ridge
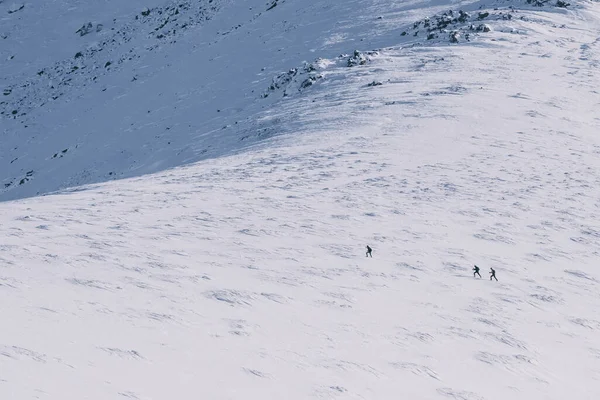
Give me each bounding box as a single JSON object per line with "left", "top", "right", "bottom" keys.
{"left": 0, "top": 0, "right": 464, "bottom": 200}
